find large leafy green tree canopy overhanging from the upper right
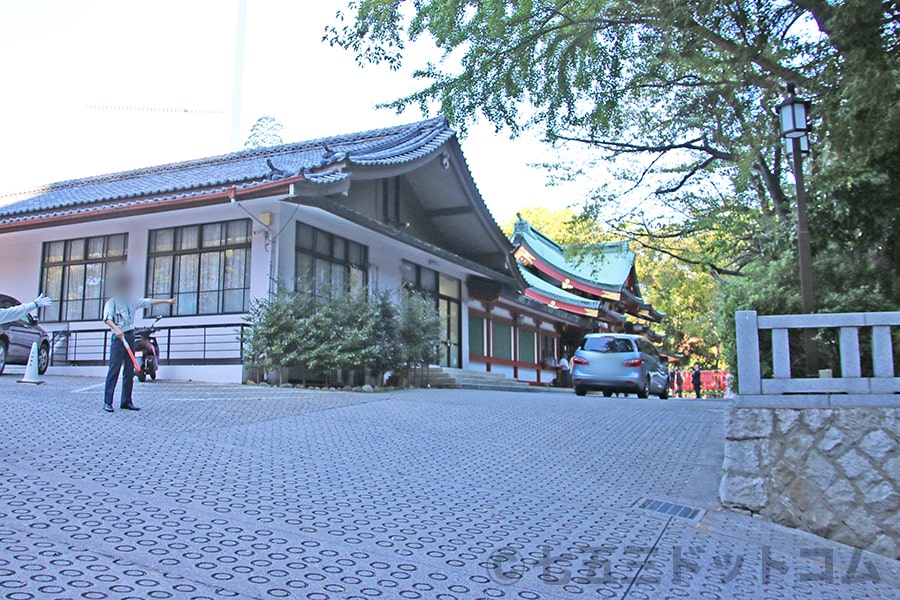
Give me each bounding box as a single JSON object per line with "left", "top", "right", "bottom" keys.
{"left": 326, "top": 0, "right": 900, "bottom": 290}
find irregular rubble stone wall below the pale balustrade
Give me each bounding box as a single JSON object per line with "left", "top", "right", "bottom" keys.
{"left": 719, "top": 396, "right": 900, "bottom": 559}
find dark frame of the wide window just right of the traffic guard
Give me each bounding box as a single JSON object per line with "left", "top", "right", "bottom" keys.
{"left": 145, "top": 219, "right": 253, "bottom": 317}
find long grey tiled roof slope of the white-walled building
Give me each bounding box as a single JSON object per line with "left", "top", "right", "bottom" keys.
{"left": 0, "top": 117, "right": 455, "bottom": 223}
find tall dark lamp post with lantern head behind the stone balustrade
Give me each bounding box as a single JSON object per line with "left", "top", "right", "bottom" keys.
{"left": 778, "top": 84, "right": 819, "bottom": 377}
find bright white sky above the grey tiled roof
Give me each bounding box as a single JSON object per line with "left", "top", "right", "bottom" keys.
{"left": 0, "top": 0, "right": 591, "bottom": 221}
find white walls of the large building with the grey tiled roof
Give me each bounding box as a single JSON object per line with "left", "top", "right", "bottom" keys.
{"left": 0, "top": 198, "right": 492, "bottom": 382}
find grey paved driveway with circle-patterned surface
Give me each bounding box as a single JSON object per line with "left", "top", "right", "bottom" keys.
{"left": 0, "top": 375, "right": 900, "bottom": 600}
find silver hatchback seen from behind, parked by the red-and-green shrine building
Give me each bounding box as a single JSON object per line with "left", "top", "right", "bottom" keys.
{"left": 572, "top": 333, "right": 669, "bottom": 399}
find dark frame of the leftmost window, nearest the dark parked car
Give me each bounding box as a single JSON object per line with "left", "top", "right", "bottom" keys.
{"left": 39, "top": 232, "right": 128, "bottom": 323}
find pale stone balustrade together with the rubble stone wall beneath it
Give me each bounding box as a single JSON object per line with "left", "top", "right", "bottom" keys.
{"left": 719, "top": 311, "right": 900, "bottom": 559}
